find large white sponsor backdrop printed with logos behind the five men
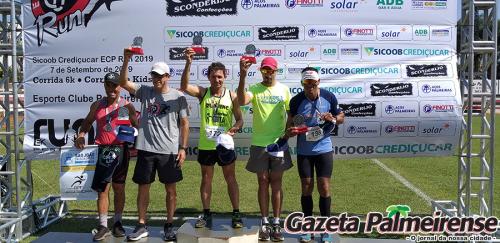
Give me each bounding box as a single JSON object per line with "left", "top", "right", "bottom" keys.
{"left": 23, "top": 0, "right": 462, "bottom": 159}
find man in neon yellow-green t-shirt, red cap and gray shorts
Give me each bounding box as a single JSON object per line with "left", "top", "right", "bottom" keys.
{"left": 237, "top": 57, "right": 293, "bottom": 241}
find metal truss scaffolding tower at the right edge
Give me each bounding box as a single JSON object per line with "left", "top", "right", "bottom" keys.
{"left": 433, "top": 0, "right": 498, "bottom": 223}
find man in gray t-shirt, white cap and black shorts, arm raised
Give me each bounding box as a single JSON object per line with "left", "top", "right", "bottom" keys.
{"left": 120, "top": 48, "right": 189, "bottom": 241}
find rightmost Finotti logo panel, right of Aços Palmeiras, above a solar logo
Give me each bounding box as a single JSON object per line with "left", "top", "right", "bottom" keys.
{"left": 420, "top": 100, "right": 462, "bottom": 117}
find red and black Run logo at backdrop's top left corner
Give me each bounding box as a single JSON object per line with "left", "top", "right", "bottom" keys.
{"left": 31, "top": 0, "right": 119, "bottom": 46}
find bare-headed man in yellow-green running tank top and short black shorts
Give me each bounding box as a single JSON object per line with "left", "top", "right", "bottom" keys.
{"left": 181, "top": 48, "right": 243, "bottom": 228}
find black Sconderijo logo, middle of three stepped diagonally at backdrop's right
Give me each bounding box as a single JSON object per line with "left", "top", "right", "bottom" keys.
{"left": 367, "top": 82, "right": 418, "bottom": 97}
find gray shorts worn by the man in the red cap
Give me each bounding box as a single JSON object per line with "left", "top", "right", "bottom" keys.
{"left": 246, "top": 145, "right": 293, "bottom": 173}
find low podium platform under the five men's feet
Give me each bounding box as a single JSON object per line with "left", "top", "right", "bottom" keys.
{"left": 34, "top": 218, "right": 412, "bottom": 243}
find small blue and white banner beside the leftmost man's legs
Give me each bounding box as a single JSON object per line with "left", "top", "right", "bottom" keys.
{"left": 59, "top": 146, "right": 98, "bottom": 200}
